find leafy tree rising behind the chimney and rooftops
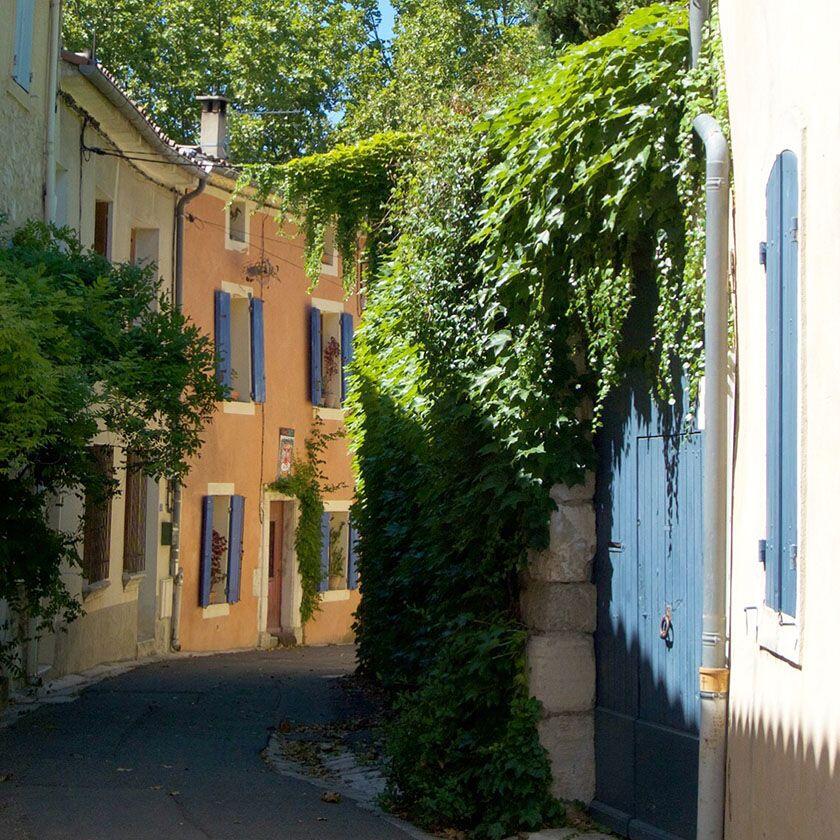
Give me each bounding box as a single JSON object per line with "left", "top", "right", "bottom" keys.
{"left": 64, "top": 0, "right": 380, "bottom": 162}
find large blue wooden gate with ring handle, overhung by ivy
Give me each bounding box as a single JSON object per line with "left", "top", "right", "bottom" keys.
{"left": 593, "top": 376, "right": 703, "bottom": 840}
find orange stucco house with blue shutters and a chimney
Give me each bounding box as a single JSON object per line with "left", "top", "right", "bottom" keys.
{"left": 174, "top": 97, "right": 361, "bottom": 651}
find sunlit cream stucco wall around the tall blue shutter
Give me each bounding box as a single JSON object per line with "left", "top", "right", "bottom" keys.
{"left": 720, "top": 0, "right": 840, "bottom": 840}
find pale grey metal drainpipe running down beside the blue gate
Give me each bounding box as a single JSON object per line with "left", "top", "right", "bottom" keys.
{"left": 689, "top": 0, "right": 729, "bottom": 840}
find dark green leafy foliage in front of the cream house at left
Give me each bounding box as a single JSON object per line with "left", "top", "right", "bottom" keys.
{"left": 0, "top": 223, "right": 222, "bottom": 666}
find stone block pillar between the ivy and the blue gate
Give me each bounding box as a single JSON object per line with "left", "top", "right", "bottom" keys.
{"left": 521, "top": 475, "right": 596, "bottom": 804}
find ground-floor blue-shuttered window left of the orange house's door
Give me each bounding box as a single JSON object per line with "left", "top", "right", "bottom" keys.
{"left": 199, "top": 496, "right": 245, "bottom": 607}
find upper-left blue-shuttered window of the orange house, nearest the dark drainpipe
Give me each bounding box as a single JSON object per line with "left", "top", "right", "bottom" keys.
{"left": 215, "top": 290, "right": 265, "bottom": 403}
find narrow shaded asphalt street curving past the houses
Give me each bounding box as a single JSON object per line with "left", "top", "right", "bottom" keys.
{"left": 0, "top": 647, "right": 408, "bottom": 840}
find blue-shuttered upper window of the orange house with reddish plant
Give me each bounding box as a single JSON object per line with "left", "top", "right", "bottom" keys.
{"left": 309, "top": 301, "right": 353, "bottom": 408}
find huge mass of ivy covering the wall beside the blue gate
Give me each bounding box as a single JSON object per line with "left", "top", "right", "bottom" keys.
{"left": 262, "top": 4, "right": 725, "bottom": 838}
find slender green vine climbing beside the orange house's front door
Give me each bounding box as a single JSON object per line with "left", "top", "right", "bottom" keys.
{"left": 268, "top": 418, "right": 344, "bottom": 625}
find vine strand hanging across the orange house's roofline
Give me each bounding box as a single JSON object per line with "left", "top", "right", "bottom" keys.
{"left": 240, "top": 132, "right": 412, "bottom": 290}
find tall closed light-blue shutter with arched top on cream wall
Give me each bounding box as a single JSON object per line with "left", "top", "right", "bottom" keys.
{"left": 764, "top": 151, "right": 799, "bottom": 616}
